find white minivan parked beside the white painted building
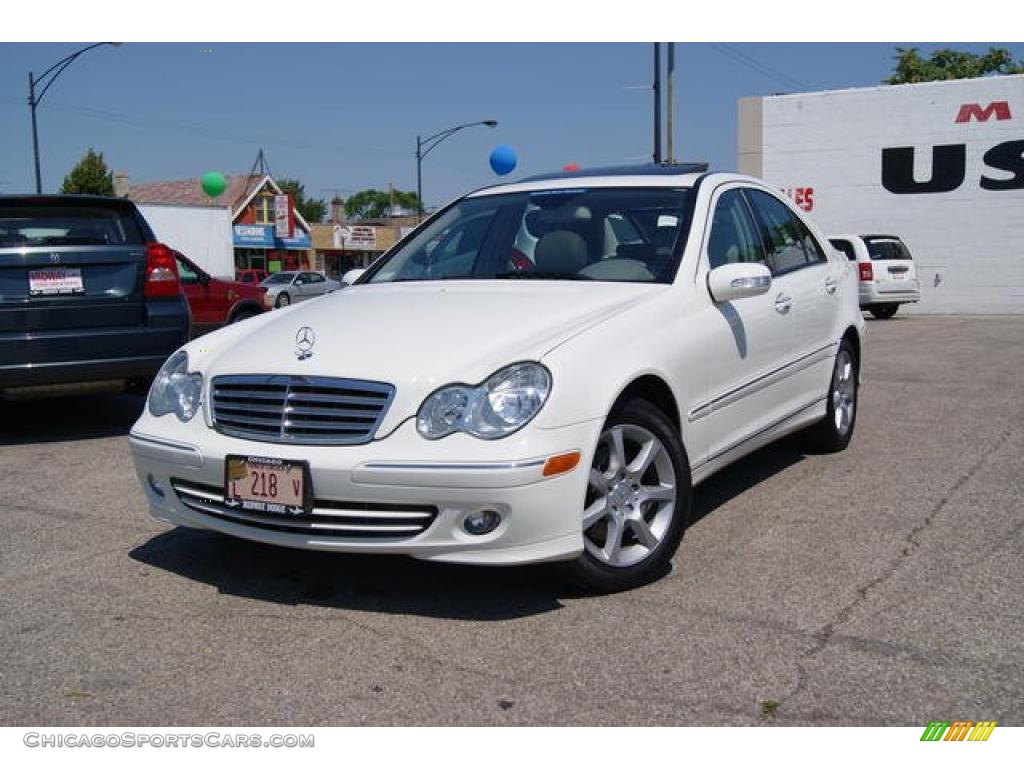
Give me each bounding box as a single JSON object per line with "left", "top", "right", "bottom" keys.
{"left": 829, "top": 234, "right": 921, "bottom": 319}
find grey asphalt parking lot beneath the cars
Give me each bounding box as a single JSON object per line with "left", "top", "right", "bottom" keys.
{"left": 0, "top": 314, "right": 1024, "bottom": 727}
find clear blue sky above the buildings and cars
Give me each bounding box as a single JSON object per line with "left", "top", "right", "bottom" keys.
{"left": 0, "top": 43, "right": 1024, "bottom": 205}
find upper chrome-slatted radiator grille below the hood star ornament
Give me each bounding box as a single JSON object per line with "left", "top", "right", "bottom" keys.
{"left": 211, "top": 376, "right": 394, "bottom": 445}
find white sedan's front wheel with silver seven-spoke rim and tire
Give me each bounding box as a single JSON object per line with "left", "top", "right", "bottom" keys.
{"left": 560, "top": 399, "right": 692, "bottom": 593}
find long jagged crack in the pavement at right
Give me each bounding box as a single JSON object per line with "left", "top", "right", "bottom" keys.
{"left": 778, "top": 428, "right": 1014, "bottom": 705}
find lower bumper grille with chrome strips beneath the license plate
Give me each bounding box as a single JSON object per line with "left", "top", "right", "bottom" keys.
{"left": 171, "top": 477, "right": 437, "bottom": 539}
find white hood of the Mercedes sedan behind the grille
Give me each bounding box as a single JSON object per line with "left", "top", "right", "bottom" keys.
{"left": 189, "top": 281, "right": 667, "bottom": 433}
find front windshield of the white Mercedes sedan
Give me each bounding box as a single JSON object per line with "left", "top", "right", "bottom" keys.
{"left": 365, "top": 187, "right": 689, "bottom": 283}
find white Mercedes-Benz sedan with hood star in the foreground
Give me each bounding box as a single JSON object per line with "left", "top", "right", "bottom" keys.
{"left": 130, "top": 165, "right": 864, "bottom": 591}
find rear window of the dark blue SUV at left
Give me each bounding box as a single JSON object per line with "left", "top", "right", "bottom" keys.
{"left": 0, "top": 205, "right": 144, "bottom": 248}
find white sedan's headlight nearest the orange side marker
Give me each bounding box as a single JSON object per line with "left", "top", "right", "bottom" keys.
{"left": 416, "top": 362, "right": 551, "bottom": 440}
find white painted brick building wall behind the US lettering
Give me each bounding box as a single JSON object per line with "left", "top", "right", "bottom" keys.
{"left": 740, "top": 76, "right": 1024, "bottom": 313}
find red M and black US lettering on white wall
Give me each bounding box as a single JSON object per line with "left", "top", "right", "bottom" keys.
{"left": 882, "top": 101, "right": 1024, "bottom": 195}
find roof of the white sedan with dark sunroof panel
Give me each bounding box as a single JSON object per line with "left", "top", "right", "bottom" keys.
{"left": 467, "top": 163, "right": 708, "bottom": 198}
